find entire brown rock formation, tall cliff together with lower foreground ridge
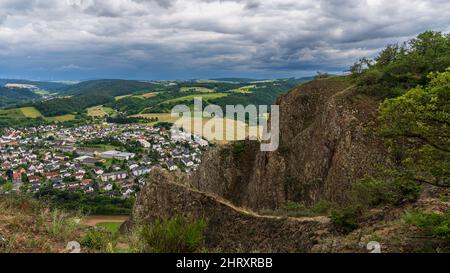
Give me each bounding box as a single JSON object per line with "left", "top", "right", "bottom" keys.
{"left": 127, "top": 79, "right": 389, "bottom": 252}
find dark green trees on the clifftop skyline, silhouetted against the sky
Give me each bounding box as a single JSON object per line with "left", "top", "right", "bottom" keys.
{"left": 350, "top": 31, "right": 450, "bottom": 98}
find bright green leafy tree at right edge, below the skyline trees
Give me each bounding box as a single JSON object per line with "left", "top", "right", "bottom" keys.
{"left": 380, "top": 68, "right": 450, "bottom": 187}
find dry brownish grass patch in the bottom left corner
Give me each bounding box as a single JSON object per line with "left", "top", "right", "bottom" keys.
{"left": 0, "top": 196, "right": 86, "bottom": 253}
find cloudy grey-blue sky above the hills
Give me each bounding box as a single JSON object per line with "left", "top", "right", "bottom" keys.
{"left": 0, "top": 0, "right": 450, "bottom": 80}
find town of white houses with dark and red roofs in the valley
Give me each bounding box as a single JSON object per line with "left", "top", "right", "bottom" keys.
{"left": 0, "top": 123, "right": 209, "bottom": 198}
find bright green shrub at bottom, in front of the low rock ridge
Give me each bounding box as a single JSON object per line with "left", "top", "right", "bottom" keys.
{"left": 139, "top": 216, "right": 207, "bottom": 253}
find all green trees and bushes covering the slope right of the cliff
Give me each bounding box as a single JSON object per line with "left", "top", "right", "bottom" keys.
{"left": 324, "top": 32, "right": 450, "bottom": 237}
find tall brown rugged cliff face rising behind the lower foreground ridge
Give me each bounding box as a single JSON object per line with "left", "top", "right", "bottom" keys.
{"left": 191, "top": 79, "right": 389, "bottom": 210}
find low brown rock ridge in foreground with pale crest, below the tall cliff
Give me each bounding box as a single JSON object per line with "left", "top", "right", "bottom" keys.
{"left": 127, "top": 169, "right": 329, "bottom": 252}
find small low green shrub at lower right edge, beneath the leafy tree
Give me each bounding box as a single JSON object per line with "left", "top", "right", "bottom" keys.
{"left": 404, "top": 211, "right": 450, "bottom": 239}
